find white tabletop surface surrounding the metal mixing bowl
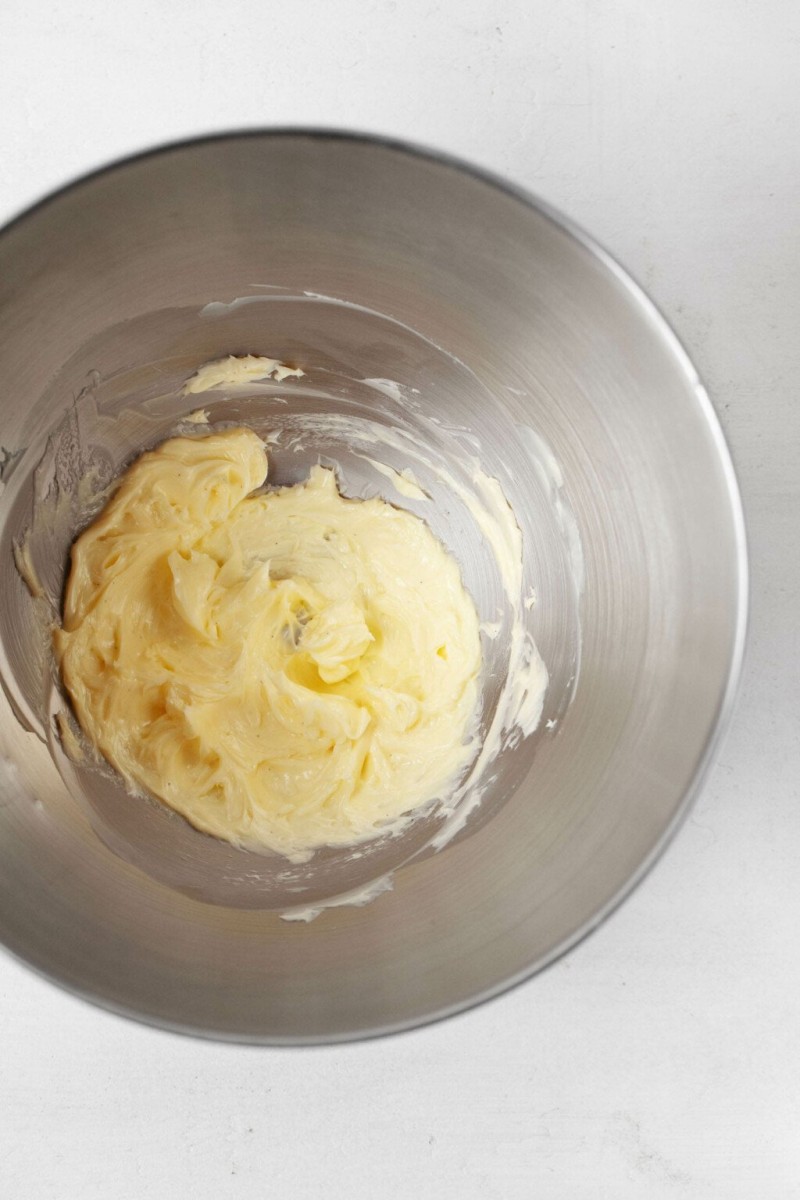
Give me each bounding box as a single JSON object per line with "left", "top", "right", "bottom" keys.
{"left": 0, "top": 0, "right": 800, "bottom": 1200}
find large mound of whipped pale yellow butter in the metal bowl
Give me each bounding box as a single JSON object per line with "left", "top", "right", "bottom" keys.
{"left": 55, "top": 428, "right": 481, "bottom": 862}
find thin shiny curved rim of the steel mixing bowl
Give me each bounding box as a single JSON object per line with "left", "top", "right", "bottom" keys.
{"left": 0, "top": 119, "right": 750, "bottom": 1049}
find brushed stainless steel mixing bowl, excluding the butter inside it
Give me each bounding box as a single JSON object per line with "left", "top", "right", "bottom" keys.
{"left": 0, "top": 132, "right": 746, "bottom": 1043}
